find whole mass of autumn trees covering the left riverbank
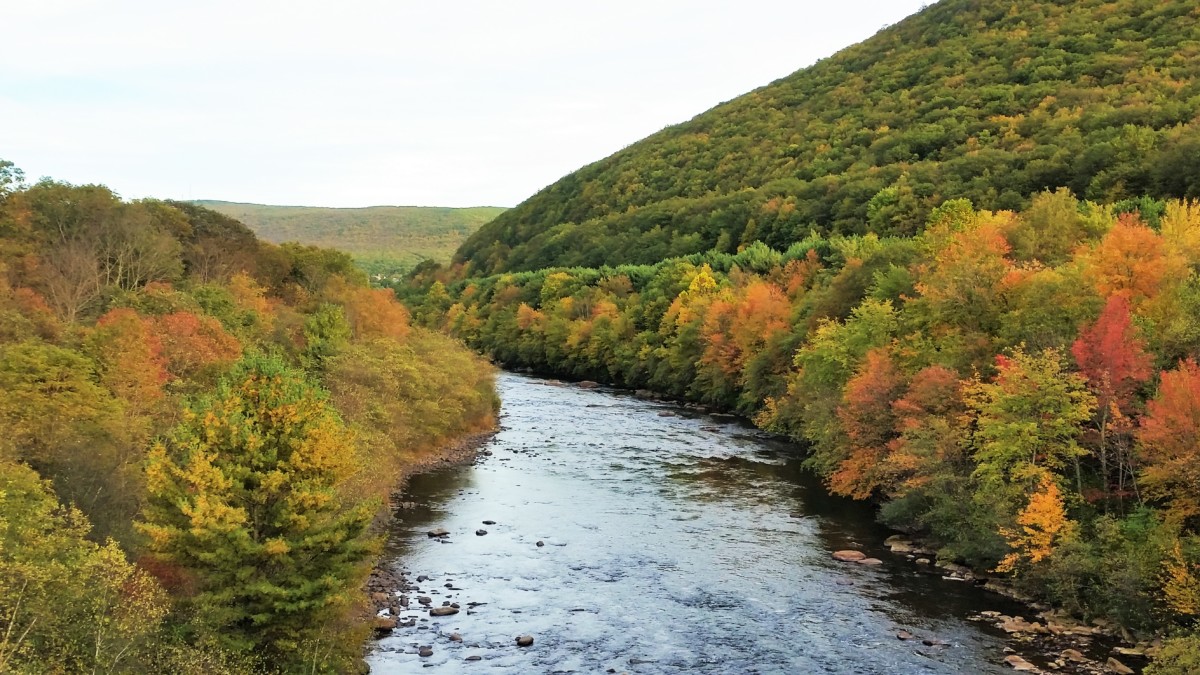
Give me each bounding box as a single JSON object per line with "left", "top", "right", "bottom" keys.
{"left": 0, "top": 161, "right": 496, "bottom": 675}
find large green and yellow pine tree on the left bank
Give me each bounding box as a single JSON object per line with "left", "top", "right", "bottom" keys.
{"left": 140, "top": 356, "right": 372, "bottom": 663}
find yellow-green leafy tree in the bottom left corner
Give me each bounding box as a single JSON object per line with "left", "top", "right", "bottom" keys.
{"left": 0, "top": 460, "right": 168, "bottom": 673}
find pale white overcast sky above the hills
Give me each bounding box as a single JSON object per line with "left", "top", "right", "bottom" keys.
{"left": 0, "top": 0, "right": 924, "bottom": 207}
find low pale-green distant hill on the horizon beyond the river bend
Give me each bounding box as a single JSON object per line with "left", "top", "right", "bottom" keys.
{"left": 194, "top": 199, "right": 504, "bottom": 275}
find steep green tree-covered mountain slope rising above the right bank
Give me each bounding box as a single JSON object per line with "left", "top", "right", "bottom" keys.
{"left": 455, "top": 0, "right": 1200, "bottom": 274}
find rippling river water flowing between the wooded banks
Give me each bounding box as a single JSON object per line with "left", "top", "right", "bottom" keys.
{"left": 367, "top": 374, "right": 1020, "bottom": 675}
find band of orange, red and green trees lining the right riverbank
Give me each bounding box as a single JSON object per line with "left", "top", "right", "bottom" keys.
{"left": 396, "top": 190, "right": 1200, "bottom": 673}
